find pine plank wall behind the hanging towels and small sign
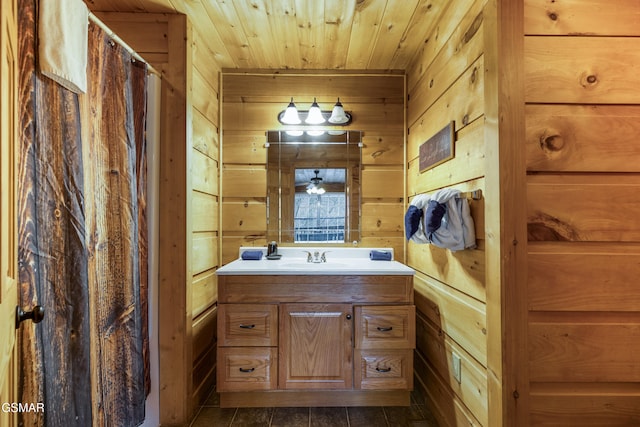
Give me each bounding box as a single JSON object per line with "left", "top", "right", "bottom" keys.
{"left": 407, "top": 0, "right": 490, "bottom": 426}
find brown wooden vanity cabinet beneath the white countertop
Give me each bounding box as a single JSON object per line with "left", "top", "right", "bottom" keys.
{"left": 217, "top": 275, "right": 415, "bottom": 407}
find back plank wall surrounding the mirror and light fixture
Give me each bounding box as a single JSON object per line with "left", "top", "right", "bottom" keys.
{"left": 222, "top": 70, "right": 405, "bottom": 264}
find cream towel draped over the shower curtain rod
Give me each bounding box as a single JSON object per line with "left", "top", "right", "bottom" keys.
{"left": 38, "top": 0, "right": 89, "bottom": 93}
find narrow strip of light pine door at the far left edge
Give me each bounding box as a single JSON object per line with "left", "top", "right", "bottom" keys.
{"left": 0, "top": 0, "right": 18, "bottom": 427}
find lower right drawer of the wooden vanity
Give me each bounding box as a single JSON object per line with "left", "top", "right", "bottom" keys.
{"left": 354, "top": 349, "right": 413, "bottom": 390}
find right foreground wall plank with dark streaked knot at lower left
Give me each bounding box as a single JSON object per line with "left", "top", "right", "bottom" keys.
{"left": 527, "top": 174, "right": 640, "bottom": 242}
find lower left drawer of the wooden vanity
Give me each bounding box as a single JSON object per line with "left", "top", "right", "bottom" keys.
{"left": 216, "top": 347, "right": 278, "bottom": 391}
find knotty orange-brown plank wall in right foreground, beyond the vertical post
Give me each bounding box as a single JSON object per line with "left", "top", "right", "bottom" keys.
{"left": 523, "top": 0, "right": 640, "bottom": 426}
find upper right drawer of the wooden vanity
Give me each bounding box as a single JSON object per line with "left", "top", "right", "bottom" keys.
{"left": 354, "top": 305, "right": 416, "bottom": 349}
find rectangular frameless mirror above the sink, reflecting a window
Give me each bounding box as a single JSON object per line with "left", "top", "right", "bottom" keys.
{"left": 267, "top": 131, "right": 362, "bottom": 244}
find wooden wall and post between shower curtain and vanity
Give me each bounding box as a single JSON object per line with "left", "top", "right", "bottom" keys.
{"left": 96, "top": 12, "right": 221, "bottom": 425}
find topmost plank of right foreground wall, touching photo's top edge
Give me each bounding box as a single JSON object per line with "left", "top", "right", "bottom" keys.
{"left": 524, "top": 0, "right": 640, "bottom": 37}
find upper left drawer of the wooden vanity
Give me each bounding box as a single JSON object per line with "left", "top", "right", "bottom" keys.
{"left": 218, "top": 304, "right": 278, "bottom": 347}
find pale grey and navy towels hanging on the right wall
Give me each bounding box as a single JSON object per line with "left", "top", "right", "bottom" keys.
{"left": 405, "top": 189, "right": 476, "bottom": 251}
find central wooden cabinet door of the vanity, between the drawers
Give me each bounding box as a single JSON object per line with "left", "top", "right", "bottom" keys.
{"left": 278, "top": 304, "right": 353, "bottom": 390}
